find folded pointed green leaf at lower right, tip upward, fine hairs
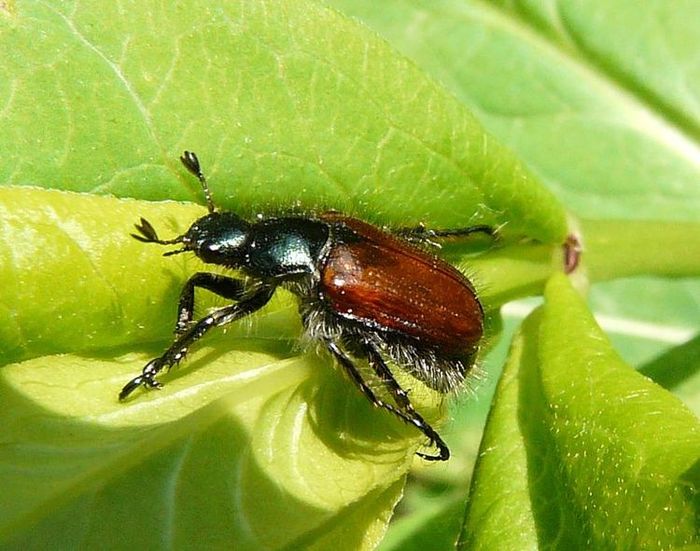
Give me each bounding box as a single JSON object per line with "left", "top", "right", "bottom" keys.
{"left": 462, "top": 276, "right": 700, "bottom": 549}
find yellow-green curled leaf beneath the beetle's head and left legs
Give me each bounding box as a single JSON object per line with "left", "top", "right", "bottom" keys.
{"left": 0, "top": 187, "right": 440, "bottom": 549}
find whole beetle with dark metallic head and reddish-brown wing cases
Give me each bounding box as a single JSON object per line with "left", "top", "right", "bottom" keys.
{"left": 119, "top": 151, "right": 494, "bottom": 461}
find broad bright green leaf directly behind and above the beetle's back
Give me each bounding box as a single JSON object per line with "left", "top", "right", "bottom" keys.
{"left": 0, "top": 0, "right": 566, "bottom": 243}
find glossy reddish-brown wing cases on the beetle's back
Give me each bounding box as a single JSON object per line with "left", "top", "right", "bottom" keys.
{"left": 321, "top": 214, "right": 483, "bottom": 355}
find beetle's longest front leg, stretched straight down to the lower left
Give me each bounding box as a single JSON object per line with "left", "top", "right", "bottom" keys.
{"left": 119, "top": 285, "right": 275, "bottom": 400}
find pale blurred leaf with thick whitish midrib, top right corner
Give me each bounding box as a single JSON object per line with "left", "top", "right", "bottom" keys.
{"left": 332, "top": 0, "right": 700, "bottom": 221}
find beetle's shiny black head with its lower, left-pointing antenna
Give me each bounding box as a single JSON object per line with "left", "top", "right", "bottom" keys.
{"left": 132, "top": 212, "right": 250, "bottom": 268}
